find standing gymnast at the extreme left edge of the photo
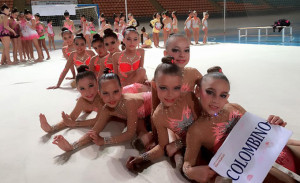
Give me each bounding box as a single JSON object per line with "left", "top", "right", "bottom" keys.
{"left": 0, "top": 4, "right": 16, "bottom": 65}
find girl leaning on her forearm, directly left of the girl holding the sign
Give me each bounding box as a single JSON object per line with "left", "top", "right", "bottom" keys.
{"left": 127, "top": 57, "right": 199, "bottom": 170}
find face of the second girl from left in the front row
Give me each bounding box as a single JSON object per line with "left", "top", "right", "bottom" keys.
{"left": 100, "top": 79, "right": 122, "bottom": 108}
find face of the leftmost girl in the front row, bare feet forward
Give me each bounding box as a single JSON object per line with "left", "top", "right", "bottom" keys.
{"left": 77, "top": 77, "right": 98, "bottom": 102}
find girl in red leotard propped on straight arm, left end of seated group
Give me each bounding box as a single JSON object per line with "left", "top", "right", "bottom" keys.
{"left": 47, "top": 34, "right": 95, "bottom": 89}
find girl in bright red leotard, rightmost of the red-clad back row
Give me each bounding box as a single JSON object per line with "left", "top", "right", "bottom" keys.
{"left": 112, "top": 27, "right": 147, "bottom": 86}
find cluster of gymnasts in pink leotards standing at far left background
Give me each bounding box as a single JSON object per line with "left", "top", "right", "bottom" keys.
{"left": 0, "top": 4, "right": 55, "bottom": 65}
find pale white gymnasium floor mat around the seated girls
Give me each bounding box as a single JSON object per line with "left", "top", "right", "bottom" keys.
{"left": 0, "top": 40, "right": 300, "bottom": 183}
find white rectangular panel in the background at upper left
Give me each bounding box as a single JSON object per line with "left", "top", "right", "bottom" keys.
{"left": 32, "top": 4, "right": 77, "bottom": 16}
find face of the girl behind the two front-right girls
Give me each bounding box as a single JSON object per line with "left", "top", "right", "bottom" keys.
{"left": 164, "top": 37, "right": 190, "bottom": 68}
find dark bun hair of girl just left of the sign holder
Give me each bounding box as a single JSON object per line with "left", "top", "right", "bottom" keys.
{"left": 154, "top": 56, "right": 182, "bottom": 80}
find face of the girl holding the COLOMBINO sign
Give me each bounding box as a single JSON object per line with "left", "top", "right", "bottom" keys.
{"left": 198, "top": 77, "right": 230, "bottom": 116}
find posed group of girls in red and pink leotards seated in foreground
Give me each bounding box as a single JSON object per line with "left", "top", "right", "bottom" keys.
{"left": 35, "top": 7, "right": 300, "bottom": 182}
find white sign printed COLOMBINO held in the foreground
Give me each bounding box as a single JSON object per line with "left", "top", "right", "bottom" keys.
{"left": 209, "top": 112, "right": 292, "bottom": 183}
